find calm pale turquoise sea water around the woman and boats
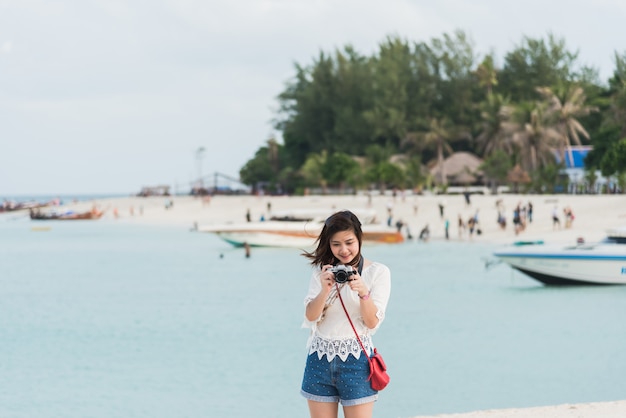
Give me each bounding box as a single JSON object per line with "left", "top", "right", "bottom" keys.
{"left": 0, "top": 218, "right": 626, "bottom": 418}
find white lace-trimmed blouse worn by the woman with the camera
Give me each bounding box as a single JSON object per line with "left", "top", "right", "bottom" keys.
{"left": 303, "top": 262, "right": 391, "bottom": 362}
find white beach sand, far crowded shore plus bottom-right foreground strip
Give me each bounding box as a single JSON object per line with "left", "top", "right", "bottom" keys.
{"left": 29, "top": 191, "right": 626, "bottom": 418}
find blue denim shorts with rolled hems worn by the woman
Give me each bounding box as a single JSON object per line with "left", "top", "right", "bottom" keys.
{"left": 300, "top": 353, "right": 378, "bottom": 406}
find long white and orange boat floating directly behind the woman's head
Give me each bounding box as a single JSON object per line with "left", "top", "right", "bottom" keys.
{"left": 197, "top": 211, "right": 404, "bottom": 248}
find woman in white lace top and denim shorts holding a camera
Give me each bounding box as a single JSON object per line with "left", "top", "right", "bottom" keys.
{"left": 301, "top": 211, "right": 391, "bottom": 418}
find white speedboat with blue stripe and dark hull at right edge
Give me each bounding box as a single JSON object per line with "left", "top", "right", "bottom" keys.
{"left": 494, "top": 228, "right": 626, "bottom": 285}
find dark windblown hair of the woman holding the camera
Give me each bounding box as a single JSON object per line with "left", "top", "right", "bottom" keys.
{"left": 302, "top": 210, "right": 363, "bottom": 267}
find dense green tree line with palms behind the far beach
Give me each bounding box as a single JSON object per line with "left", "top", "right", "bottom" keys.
{"left": 240, "top": 30, "right": 626, "bottom": 193}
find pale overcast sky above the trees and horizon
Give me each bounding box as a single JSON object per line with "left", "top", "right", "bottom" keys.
{"left": 0, "top": 0, "right": 626, "bottom": 199}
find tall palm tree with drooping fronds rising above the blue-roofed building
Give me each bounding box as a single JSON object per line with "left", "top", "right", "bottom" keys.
{"left": 537, "top": 86, "right": 598, "bottom": 164}
